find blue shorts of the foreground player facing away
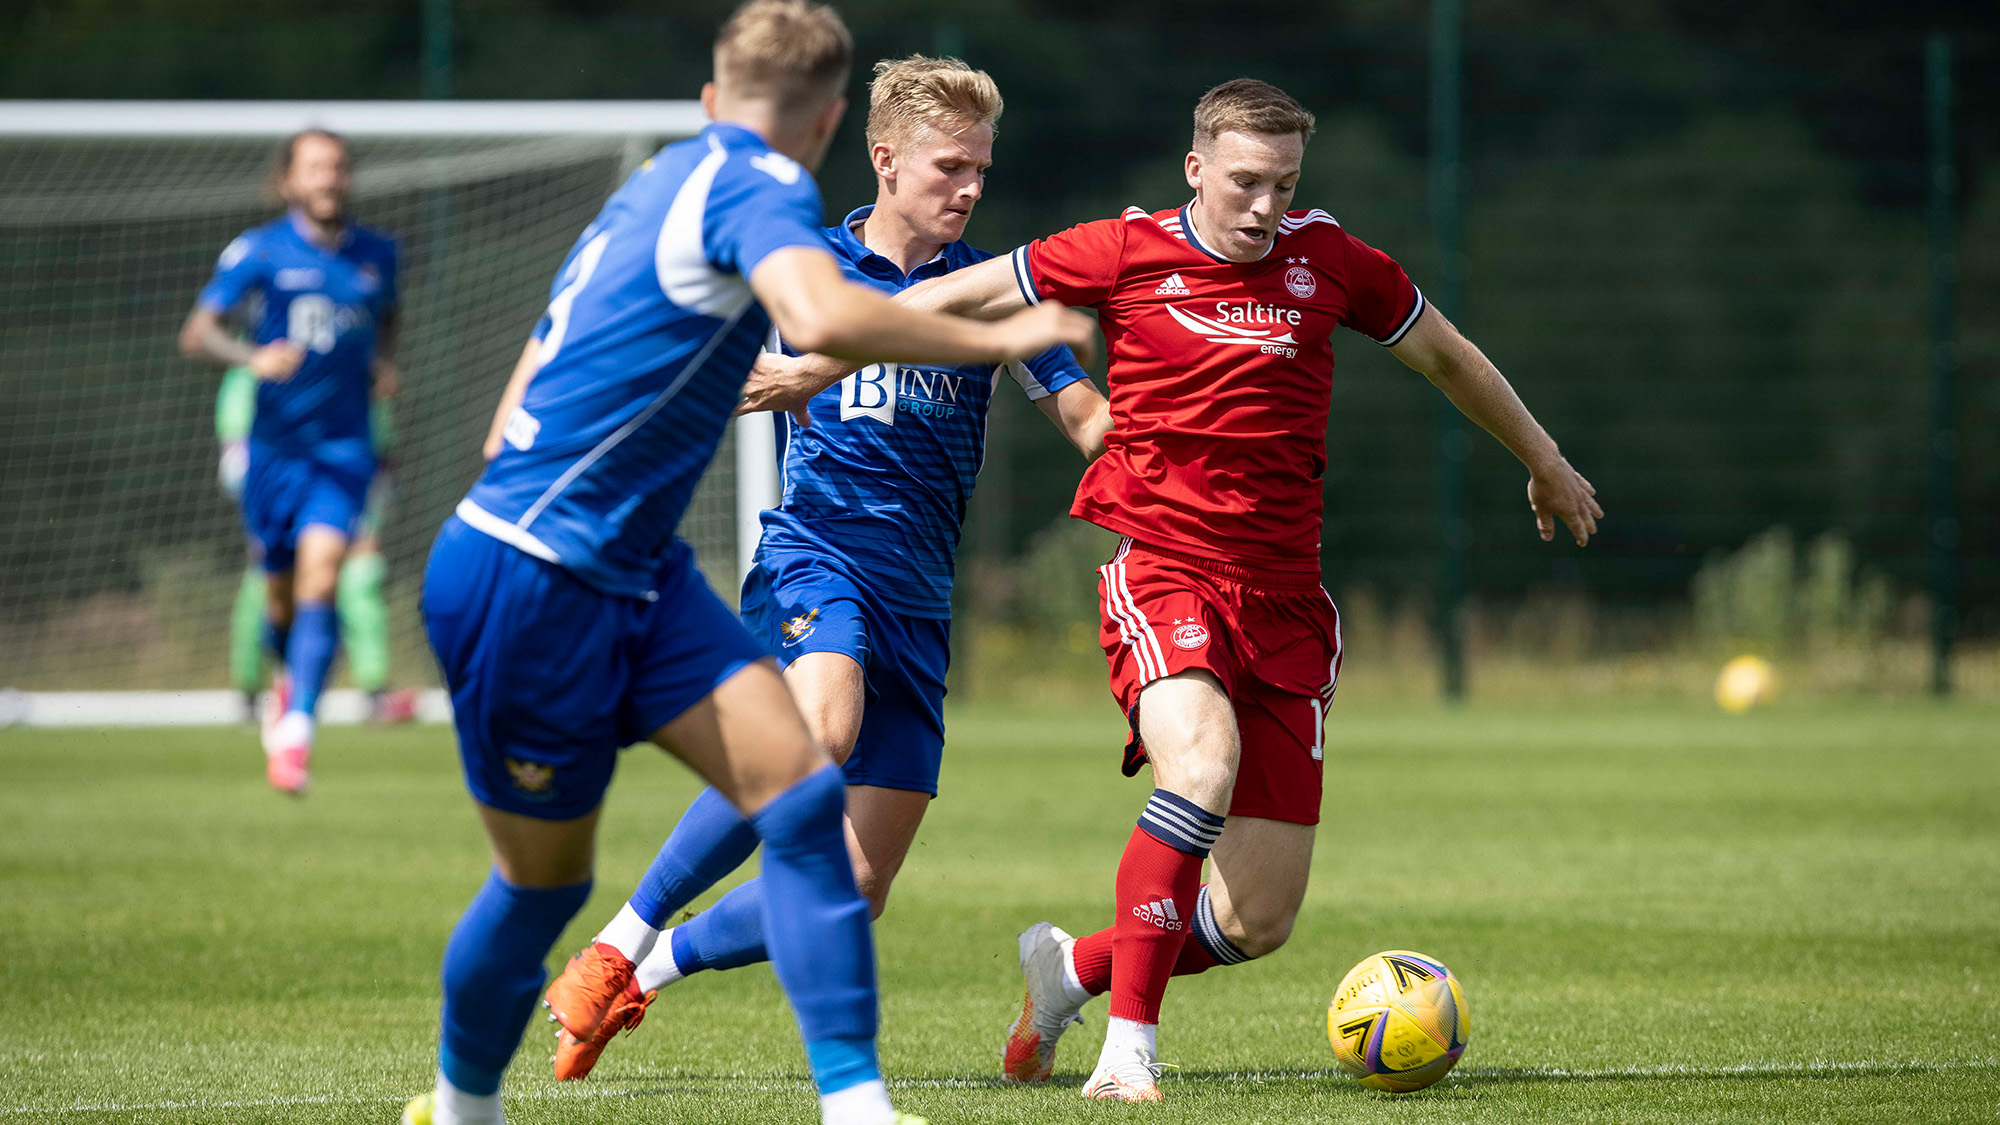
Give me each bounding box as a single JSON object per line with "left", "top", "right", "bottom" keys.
{"left": 424, "top": 516, "right": 770, "bottom": 821}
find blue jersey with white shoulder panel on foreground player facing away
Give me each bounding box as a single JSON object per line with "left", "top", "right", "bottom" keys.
{"left": 458, "top": 124, "right": 826, "bottom": 597}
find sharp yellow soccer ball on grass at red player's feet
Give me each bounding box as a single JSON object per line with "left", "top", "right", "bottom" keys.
{"left": 1326, "top": 949, "right": 1472, "bottom": 1093}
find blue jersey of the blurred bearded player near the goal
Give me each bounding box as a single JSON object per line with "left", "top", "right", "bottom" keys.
{"left": 200, "top": 214, "right": 396, "bottom": 468}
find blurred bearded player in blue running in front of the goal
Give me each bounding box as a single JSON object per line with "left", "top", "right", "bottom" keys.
{"left": 180, "top": 128, "right": 398, "bottom": 795}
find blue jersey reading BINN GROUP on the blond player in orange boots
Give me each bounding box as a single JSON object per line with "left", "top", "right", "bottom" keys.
{"left": 758, "top": 206, "right": 1088, "bottom": 619}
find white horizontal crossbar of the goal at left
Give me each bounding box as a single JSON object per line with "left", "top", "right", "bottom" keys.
{"left": 0, "top": 100, "right": 708, "bottom": 138}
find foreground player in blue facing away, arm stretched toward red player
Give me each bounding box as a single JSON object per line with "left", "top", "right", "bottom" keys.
{"left": 404, "top": 8, "right": 1094, "bottom": 1125}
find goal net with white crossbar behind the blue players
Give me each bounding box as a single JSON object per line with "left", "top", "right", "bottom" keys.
{"left": 0, "top": 102, "right": 770, "bottom": 691}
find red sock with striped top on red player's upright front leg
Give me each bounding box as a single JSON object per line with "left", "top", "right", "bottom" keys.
{"left": 1104, "top": 789, "right": 1222, "bottom": 1023}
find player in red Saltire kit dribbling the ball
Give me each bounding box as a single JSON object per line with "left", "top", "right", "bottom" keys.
{"left": 750, "top": 78, "right": 1604, "bottom": 1101}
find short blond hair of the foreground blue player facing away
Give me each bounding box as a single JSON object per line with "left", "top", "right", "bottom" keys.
{"left": 716, "top": 0, "right": 854, "bottom": 118}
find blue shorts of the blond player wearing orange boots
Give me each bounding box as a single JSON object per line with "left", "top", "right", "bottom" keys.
{"left": 742, "top": 550, "right": 952, "bottom": 797}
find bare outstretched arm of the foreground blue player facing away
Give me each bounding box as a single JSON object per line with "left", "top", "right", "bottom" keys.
{"left": 750, "top": 246, "right": 1096, "bottom": 364}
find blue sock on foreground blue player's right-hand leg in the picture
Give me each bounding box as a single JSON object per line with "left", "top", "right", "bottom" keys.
{"left": 752, "top": 765, "right": 882, "bottom": 1095}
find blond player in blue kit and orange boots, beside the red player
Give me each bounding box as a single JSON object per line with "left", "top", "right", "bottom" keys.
{"left": 548, "top": 56, "right": 1110, "bottom": 1079}
